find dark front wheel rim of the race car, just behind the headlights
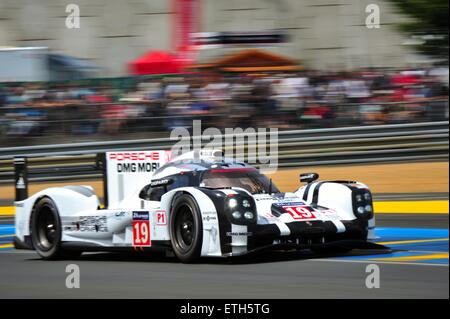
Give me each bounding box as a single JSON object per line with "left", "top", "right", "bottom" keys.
{"left": 175, "top": 205, "right": 196, "bottom": 252}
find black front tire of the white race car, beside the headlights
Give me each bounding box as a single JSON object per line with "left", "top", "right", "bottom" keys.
{"left": 169, "top": 194, "right": 203, "bottom": 263}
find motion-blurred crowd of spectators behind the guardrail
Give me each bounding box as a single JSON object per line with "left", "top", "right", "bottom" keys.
{"left": 0, "top": 69, "right": 448, "bottom": 143}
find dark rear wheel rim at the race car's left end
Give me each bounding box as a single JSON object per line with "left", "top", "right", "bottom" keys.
{"left": 37, "top": 206, "right": 56, "bottom": 250}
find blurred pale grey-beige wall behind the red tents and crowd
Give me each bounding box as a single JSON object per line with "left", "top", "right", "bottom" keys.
{"left": 0, "top": 0, "right": 415, "bottom": 76}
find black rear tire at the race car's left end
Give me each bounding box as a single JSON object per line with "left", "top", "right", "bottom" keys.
{"left": 31, "top": 197, "right": 82, "bottom": 259}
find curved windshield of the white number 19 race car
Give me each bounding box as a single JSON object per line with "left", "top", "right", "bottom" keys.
{"left": 200, "top": 168, "right": 280, "bottom": 194}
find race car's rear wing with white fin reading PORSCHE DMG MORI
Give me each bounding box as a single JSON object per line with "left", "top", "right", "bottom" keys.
{"left": 14, "top": 151, "right": 172, "bottom": 208}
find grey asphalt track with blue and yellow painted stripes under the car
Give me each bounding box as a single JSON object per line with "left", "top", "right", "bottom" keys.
{"left": 0, "top": 214, "right": 449, "bottom": 298}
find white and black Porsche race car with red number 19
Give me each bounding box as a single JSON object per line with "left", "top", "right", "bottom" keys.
{"left": 15, "top": 150, "right": 375, "bottom": 262}
